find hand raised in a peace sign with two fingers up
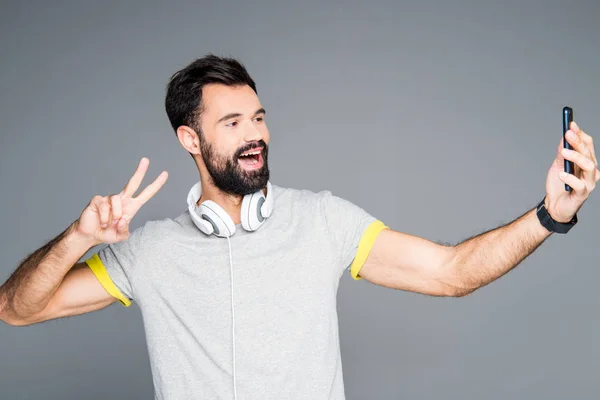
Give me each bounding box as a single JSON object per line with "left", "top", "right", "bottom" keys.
{"left": 76, "top": 157, "right": 168, "bottom": 244}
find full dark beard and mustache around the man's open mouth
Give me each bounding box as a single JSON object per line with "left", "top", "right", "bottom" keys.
{"left": 200, "top": 135, "right": 269, "bottom": 196}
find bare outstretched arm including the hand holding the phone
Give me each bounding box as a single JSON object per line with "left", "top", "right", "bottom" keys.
{"left": 360, "top": 123, "right": 600, "bottom": 296}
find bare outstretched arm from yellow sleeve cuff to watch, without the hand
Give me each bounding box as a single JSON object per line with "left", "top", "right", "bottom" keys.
{"left": 360, "top": 209, "right": 550, "bottom": 296}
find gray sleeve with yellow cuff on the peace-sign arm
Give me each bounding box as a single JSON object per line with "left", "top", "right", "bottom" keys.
{"left": 85, "top": 226, "right": 144, "bottom": 307}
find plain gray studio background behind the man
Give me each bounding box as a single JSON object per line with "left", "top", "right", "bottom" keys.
{"left": 0, "top": 0, "right": 600, "bottom": 399}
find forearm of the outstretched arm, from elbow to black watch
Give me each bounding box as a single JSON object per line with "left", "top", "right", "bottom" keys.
{"left": 450, "top": 205, "right": 551, "bottom": 294}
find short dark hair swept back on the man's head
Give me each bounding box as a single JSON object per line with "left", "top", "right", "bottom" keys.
{"left": 165, "top": 54, "right": 256, "bottom": 133}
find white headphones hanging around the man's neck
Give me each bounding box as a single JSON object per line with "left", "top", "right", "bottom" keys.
{"left": 187, "top": 182, "right": 274, "bottom": 237}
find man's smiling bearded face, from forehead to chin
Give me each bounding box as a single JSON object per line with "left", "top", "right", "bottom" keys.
{"left": 200, "top": 84, "right": 269, "bottom": 196}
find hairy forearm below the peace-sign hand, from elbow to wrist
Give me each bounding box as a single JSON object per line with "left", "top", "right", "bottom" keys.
{"left": 0, "top": 222, "right": 96, "bottom": 321}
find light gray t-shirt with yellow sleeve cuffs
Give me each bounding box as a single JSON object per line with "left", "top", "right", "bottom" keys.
{"left": 86, "top": 185, "right": 385, "bottom": 400}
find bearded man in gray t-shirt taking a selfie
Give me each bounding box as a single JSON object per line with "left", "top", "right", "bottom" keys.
{"left": 0, "top": 55, "right": 600, "bottom": 400}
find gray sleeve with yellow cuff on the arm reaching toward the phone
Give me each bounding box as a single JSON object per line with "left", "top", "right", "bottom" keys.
{"left": 321, "top": 191, "right": 387, "bottom": 280}
